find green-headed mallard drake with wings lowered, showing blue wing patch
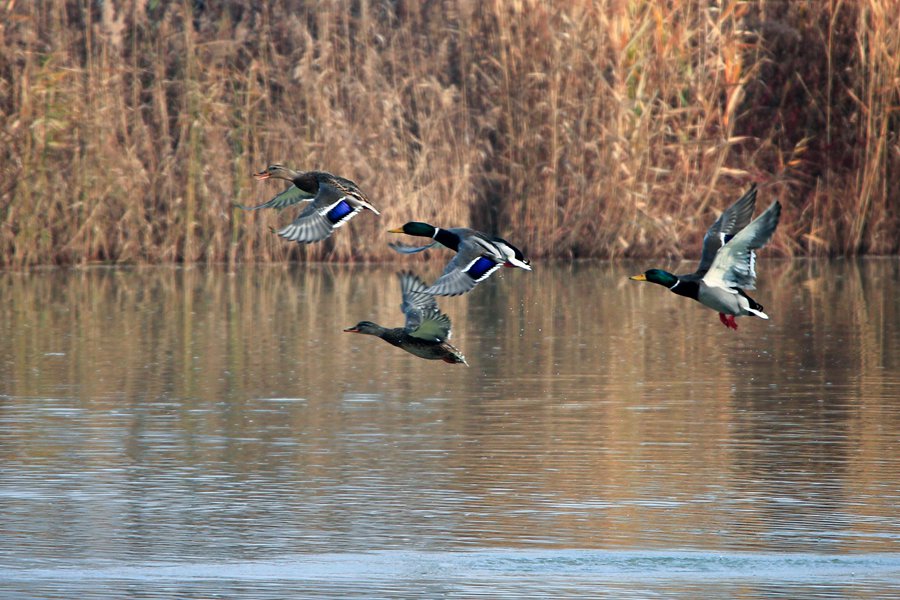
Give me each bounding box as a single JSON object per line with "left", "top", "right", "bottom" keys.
{"left": 388, "top": 221, "right": 531, "bottom": 296}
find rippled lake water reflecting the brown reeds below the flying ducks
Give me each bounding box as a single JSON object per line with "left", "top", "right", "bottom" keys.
{"left": 0, "top": 259, "right": 900, "bottom": 598}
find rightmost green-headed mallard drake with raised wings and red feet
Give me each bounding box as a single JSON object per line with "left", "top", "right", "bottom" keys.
{"left": 630, "top": 186, "right": 781, "bottom": 329}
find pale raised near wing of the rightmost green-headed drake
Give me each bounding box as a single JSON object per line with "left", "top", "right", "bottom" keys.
{"left": 703, "top": 200, "right": 781, "bottom": 290}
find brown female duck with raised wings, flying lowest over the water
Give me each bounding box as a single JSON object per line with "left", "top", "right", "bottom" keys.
{"left": 344, "top": 272, "right": 469, "bottom": 366}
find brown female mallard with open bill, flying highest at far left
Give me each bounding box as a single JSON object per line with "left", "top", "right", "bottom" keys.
{"left": 237, "top": 164, "right": 379, "bottom": 244}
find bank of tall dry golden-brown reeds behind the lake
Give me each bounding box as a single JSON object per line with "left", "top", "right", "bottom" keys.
{"left": 0, "top": 0, "right": 900, "bottom": 265}
